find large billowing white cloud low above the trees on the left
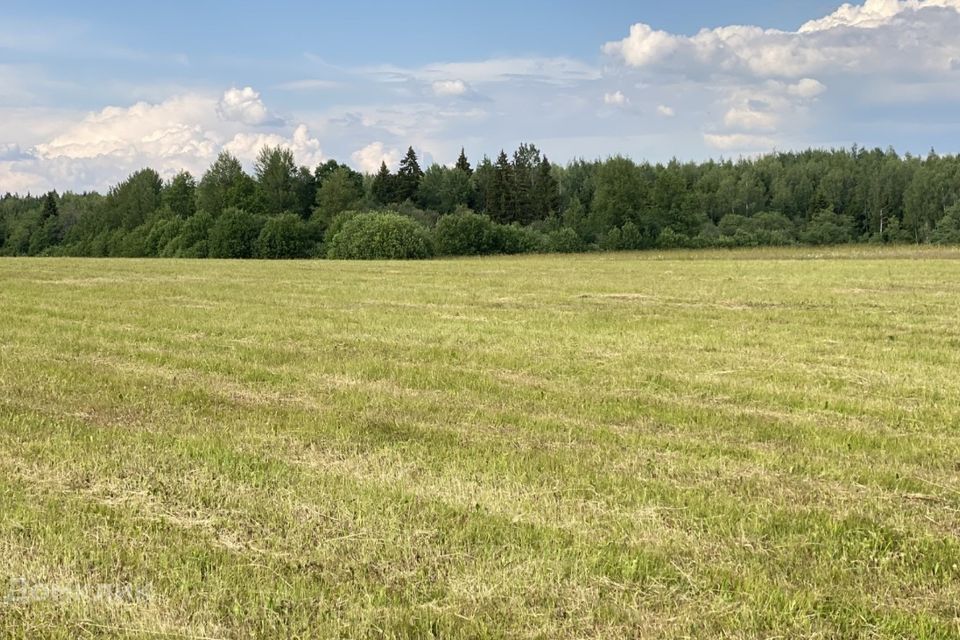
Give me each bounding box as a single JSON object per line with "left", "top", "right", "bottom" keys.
{"left": 0, "top": 89, "right": 324, "bottom": 191}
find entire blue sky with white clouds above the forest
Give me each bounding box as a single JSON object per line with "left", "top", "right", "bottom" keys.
{"left": 0, "top": 0, "right": 960, "bottom": 193}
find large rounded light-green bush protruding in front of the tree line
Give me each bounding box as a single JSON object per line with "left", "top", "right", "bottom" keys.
{"left": 327, "top": 213, "right": 433, "bottom": 260}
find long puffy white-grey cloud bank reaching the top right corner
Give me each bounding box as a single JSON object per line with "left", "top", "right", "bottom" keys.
{"left": 603, "top": 0, "right": 960, "bottom": 78}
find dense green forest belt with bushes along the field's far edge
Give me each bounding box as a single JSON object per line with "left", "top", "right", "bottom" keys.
{"left": 0, "top": 144, "right": 960, "bottom": 258}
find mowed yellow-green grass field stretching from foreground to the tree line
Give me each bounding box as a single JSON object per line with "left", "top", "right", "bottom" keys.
{"left": 0, "top": 249, "right": 960, "bottom": 639}
